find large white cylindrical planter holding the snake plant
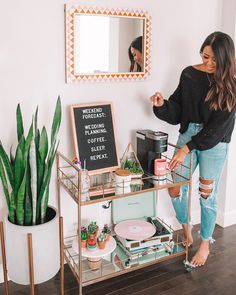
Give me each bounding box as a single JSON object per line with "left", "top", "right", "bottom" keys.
{"left": 4, "top": 207, "right": 60, "bottom": 285}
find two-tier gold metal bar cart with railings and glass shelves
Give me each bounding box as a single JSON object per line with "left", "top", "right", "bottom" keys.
{"left": 56, "top": 143, "right": 192, "bottom": 295}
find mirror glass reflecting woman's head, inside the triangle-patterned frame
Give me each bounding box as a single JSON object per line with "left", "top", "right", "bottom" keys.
{"left": 74, "top": 13, "right": 146, "bottom": 75}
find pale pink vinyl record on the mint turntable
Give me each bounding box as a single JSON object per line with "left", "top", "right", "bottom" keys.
{"left": 114, "top": 220, "right": 156, "bottom": 241}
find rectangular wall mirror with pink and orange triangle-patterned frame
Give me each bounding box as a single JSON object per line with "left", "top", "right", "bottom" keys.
{"left": 65, "top": 4, "right": 150, "bottom": 83}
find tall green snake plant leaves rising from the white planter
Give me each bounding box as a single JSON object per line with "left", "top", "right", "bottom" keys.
{"left": 0, "top": 97, "right": 61, "bottom": 225}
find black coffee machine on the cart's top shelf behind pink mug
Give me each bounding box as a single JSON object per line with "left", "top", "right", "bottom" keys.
{"left": 136, "top": 129, "right": 168, "bottom": 175}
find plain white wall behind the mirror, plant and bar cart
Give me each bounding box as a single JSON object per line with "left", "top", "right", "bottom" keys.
{"left": 0, "top": 0, "right": 235, "bottom": 284}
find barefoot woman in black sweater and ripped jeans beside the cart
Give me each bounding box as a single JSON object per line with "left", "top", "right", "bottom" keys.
{"left": 150, "top": 32, "right": 236, "bottom": 266}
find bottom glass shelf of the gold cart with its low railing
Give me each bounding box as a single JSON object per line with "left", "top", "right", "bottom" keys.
{"left": 64, "top": 232, "right": 185, "bottom": 286}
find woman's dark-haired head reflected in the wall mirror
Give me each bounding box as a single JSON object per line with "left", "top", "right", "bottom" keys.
{"left": 128, "top": 36, "right": 143, "bottom": 72}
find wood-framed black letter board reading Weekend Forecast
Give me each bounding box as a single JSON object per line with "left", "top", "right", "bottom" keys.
{"left": 70, "top": 102, "right": 120, "bottom": 175}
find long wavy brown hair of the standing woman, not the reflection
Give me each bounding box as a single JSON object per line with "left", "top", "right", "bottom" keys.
{"left": 200, "top": 32, "right": 236, "bottom": 112}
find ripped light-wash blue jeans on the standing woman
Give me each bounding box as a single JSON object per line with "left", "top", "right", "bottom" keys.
{"left": 171, "top": 123, "right": 228, "bottom": 241}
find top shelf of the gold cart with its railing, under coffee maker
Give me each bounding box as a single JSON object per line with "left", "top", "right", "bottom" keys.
{"left": 58, "top": 152, "right": 190, "bottom": 206}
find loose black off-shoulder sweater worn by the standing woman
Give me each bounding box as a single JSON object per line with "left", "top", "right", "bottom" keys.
{"left": 153, "top": 66, "right": 236, "bottom": 151}
